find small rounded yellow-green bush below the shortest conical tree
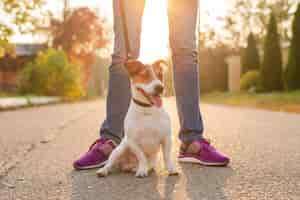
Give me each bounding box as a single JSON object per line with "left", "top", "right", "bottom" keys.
{"left": 240, "top": 70, "right": 259, "bottom": 90}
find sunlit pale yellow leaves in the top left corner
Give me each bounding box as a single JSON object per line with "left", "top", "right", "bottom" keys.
{"left": 0, "top": 0, "right": 45, "bottom": 40}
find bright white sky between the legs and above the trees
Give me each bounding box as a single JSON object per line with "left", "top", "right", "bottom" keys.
{"left": 12, "top": 0, "right": 229, "bottom": 62}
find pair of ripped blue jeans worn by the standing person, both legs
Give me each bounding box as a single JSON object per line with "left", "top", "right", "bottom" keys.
{"left": 100, "top": 0, "right": 203, "bottom": 143}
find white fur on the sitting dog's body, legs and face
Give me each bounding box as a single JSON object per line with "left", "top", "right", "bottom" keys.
{"left": 97, "top": 69, "right": 177, "bottom": 177}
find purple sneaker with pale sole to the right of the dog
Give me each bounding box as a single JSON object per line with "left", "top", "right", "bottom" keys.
{"left": 178, "top": 139, "right": 229, "bottom": 166}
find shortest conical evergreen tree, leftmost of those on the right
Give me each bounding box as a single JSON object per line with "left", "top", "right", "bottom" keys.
{"left": 242, "top": 33, "right": 260, "bottom": 74}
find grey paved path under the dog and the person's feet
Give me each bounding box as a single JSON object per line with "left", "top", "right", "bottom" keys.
{"left": 0, "top": 99, "right": 300, "bottom": 200}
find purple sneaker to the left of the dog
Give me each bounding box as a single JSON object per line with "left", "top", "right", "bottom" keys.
{"left": 73, "top": 138, "right": 116, "bottom": 170}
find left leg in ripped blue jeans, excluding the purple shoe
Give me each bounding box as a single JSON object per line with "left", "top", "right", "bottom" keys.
{"left": 100, "top": 0, "right": 144, "bottom": 143}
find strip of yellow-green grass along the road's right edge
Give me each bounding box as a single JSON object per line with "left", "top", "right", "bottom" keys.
{"left": 201, "top": 90, "right": 300, "bottom": 113}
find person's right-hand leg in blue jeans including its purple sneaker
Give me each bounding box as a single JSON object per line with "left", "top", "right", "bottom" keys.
{"left": 168, "top": 0, "right": 229, "bottom": 166}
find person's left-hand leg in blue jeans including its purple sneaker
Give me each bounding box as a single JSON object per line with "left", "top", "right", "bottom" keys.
{"left": 73, "top": 0, "right": 144, "bottom": 169}
